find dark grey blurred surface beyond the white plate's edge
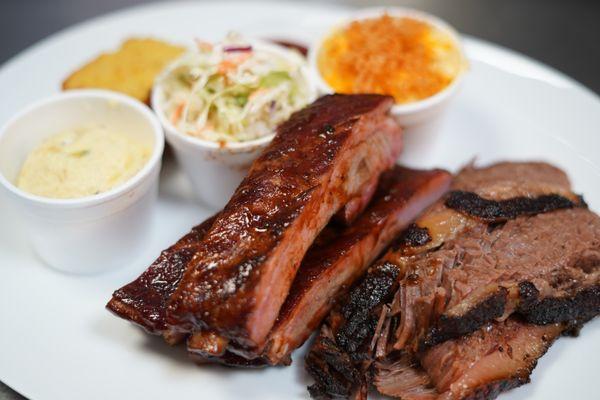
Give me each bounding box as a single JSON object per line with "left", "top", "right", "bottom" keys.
{"left": 0, "top": 0, "right": 600, "bottom": 400}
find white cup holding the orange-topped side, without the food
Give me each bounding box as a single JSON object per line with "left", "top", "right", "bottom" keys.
{"left": 308, "top": 7, "right": 468, "bottom": 128}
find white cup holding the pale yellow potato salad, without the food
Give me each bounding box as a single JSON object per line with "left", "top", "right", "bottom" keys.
{"left": 0, "top": 90, "right": 164, "bottom": 274}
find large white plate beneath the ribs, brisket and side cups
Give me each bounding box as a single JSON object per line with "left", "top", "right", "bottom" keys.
{"left": 0, "top": 3, "right": 600, "bottom": 400}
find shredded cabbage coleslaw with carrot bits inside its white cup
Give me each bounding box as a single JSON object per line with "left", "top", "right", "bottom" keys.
{"left": 159, "top": 34, "right": 311, "bottom": 142}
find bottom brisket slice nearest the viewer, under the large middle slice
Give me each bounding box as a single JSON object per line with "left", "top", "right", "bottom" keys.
{"left": 373, "top": 318, "right": 564, "bottom": 400}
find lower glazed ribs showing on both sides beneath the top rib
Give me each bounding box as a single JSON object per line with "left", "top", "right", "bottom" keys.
{"left": 108, "top": 166, "right": 451, "bottom": 367}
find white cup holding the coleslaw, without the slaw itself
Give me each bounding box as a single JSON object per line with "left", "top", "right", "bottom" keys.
{"left": 152, "top": 39, "right": 317, "bottom": 211}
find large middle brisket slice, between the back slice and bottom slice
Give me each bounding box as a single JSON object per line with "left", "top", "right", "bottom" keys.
{"left": 395, "top": 208, "right": 600, "bottom": 351}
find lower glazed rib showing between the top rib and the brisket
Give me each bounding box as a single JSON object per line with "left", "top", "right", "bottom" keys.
{"left": 188, "top": 166, "right": 451, "bottom": 366}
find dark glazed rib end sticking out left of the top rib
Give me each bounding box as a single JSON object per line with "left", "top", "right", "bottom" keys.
{"left": 106, "top": 216, "right": 215, "bottom": 344}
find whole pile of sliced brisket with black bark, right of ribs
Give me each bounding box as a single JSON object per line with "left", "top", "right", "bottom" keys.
{"left": 307, "top": 163, "right": 600, "bottom": 399}
